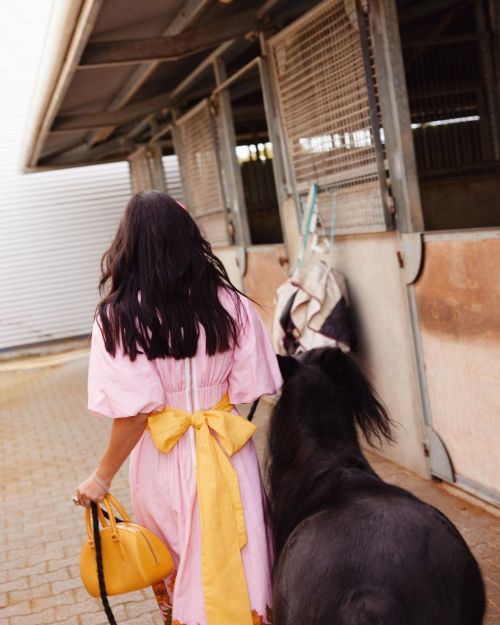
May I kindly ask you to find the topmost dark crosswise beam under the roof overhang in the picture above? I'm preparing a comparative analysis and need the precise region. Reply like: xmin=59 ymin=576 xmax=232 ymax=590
xmin=80 ymin=12 xmax=259 ymax=69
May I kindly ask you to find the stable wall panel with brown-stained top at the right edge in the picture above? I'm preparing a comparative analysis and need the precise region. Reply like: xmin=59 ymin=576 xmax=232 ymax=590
xmin=415 ymin=230 xmax=500 ymax=502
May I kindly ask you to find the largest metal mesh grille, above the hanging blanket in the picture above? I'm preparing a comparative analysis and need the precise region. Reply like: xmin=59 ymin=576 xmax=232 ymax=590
xmin=270 ymin=0 xmax=386 ymax=231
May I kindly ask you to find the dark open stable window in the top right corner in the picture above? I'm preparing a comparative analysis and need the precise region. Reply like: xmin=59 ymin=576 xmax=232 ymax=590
xmin=397 ymin=0 xmax=500 ymax=230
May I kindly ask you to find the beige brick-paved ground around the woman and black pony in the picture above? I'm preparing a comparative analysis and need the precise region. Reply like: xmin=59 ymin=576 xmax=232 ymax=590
xmin=0 ymin=357 xmax=500 ymax=625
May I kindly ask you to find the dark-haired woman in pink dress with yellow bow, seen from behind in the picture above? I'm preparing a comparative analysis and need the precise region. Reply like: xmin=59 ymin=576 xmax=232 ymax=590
xmin=76 ymin=191 xmax=282 ymax=625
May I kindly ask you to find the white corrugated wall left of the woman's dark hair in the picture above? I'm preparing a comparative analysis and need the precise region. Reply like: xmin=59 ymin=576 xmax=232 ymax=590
xmin=0 ymin=163 xmax=130 ymax=349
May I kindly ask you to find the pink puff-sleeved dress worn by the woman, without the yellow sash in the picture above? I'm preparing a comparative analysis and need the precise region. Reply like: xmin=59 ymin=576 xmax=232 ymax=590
xmin=88 ymin=289 xmax=282 ymax=625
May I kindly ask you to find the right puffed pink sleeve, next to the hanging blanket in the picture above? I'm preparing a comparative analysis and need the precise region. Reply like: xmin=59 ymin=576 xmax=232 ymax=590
xmin=228 ymin=298 xmax=283 ymax=404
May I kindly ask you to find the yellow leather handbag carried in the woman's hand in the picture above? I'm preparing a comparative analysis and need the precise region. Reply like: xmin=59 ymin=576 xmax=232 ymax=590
xmin=80 ymin=493 xmax=174 ymax=598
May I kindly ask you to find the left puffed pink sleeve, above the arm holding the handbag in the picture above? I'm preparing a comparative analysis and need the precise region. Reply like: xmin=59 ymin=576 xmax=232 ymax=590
xmin=88 ymin=321 xmax=164 ymax=418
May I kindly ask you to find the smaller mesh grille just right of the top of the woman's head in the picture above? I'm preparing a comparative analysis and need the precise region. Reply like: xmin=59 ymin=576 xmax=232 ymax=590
xmin=177 ymin=101 xmax=230 ymax=245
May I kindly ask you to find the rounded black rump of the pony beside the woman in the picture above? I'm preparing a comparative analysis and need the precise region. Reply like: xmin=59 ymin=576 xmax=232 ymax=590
xmin=273 ymin=488 xmax=485 ymax=625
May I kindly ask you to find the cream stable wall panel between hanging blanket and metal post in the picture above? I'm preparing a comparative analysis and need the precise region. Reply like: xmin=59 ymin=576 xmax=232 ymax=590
xmin=333 ymin=232 xmax=428 ymax=476
